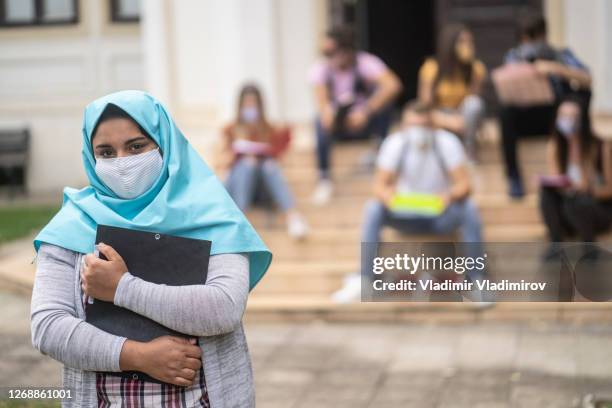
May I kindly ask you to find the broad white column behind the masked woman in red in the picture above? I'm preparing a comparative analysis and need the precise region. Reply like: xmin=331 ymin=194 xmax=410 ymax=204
xmin=173 ymin=0 xmax=279 ymax=123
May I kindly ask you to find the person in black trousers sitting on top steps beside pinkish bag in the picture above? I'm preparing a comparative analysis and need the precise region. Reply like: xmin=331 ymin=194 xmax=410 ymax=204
xmin=499 ymin=15 xmax=591 ymax=198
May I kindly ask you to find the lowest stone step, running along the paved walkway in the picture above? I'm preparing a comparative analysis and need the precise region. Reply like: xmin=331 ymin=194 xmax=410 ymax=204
xmin=246 ymin=295 xmax=612 ymax=325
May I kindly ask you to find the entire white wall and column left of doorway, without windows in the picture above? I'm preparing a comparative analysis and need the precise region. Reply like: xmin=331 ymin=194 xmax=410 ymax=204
xmin=0 ymin=0 xmax=325 ymax=193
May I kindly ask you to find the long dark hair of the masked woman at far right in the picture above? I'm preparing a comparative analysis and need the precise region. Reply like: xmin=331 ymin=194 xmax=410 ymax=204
xmin=551 ymin=94 xmax=602 ymax=172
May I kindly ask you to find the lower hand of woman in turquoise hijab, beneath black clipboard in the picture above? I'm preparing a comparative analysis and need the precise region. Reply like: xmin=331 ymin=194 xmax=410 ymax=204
xmin=119 ymin=336 xmax=202 ymax=386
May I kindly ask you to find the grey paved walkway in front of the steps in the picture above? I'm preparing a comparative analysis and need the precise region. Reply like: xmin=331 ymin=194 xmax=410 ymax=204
xmin=0 ymin=292 xmax=612 ymax=408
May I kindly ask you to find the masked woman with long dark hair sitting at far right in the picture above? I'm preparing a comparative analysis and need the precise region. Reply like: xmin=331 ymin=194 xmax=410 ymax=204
xmin=540 ymin=95 xmax=612 ymax=254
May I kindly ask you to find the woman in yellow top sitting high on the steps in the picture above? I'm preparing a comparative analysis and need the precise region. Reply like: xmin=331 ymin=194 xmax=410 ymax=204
xmin=418 ymin=24 xmax=487 ymax=159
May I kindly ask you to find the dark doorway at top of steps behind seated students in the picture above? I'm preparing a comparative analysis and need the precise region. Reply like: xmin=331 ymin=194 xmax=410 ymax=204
xmin=329 ymin=0 xmax=542 ymax=112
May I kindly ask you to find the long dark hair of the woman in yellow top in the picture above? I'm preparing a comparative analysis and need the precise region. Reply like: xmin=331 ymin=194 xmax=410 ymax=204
xmin=434 ymin=23 xmax=472 ymax=88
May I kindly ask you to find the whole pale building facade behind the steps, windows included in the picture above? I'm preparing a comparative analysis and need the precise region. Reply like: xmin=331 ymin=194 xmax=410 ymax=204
xmin=0 ymin=0 xmax=612 ymax=193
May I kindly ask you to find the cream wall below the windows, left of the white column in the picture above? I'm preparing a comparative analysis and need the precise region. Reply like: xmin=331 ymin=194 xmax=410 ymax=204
xmin=0 ymin=0 xmax=144 ymax=193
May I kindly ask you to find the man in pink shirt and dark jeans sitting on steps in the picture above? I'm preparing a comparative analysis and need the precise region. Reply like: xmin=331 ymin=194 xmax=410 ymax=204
xmin=309 ymin=26 xmax=402 ymax=204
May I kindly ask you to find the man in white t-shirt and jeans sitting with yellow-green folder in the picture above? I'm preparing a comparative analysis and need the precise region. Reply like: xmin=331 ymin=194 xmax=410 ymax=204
xmin=333 ymin=101 xmax=482 ymax=303
